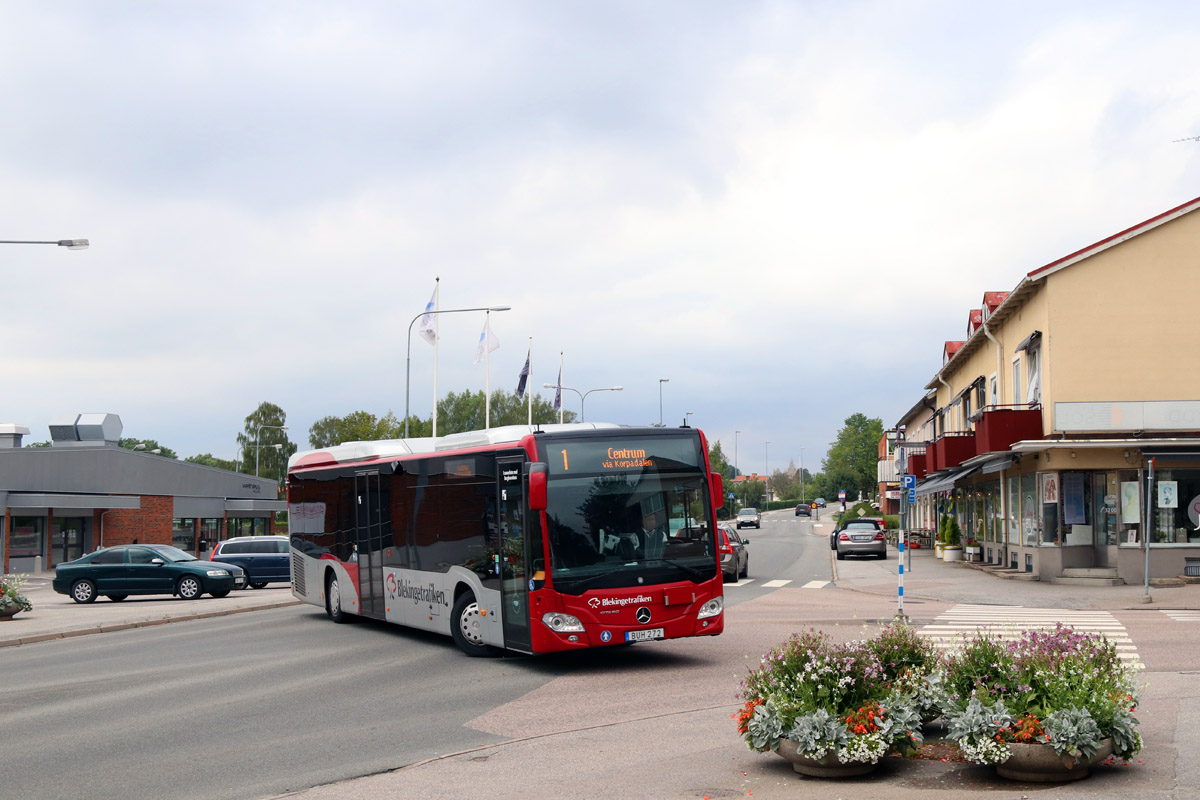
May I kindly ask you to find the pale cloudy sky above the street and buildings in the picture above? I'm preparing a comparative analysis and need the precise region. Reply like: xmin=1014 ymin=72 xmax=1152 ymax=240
xmin=0 ymin=0 xmax=1200 ymax=471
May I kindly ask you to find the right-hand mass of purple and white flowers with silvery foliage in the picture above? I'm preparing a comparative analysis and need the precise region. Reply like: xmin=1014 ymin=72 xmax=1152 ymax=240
xmin=946 ymin=622 xmax=1141 ymax=764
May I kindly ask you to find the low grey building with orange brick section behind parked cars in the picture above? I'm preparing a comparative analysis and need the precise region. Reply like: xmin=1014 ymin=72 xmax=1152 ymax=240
xmin=0 ymin=414 xmax=287 ymax=572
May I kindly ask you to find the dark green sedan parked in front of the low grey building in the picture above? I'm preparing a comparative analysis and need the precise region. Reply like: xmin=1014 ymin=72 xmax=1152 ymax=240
xmin=52 ymin=545 xmax=246 ymax=603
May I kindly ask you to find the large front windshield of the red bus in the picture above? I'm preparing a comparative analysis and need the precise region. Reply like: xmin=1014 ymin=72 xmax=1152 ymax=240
xmin=546 ymin=462 xmax=716 ymax=595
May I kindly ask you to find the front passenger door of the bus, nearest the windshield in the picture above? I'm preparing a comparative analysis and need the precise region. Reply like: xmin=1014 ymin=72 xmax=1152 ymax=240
xmin=496 ymin=457 xmax=530 ymax=652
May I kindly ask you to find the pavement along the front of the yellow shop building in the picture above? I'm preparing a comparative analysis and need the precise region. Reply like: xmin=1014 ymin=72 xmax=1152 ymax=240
xmin=830 ymin=549 xmax=1200 ymax=610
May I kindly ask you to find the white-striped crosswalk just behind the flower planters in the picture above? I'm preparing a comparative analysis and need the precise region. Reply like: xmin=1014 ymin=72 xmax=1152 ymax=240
xmin=917 ymin=603 xmax=1137 ymax=668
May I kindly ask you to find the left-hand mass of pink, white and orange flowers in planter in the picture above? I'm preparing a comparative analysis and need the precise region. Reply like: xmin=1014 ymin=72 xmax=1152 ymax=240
xmin=733 ymin=626 xmax=922 ymax=764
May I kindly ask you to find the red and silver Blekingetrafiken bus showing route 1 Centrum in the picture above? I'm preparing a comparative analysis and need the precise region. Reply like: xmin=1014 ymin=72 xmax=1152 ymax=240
xmin=288 ymin=422 xmax=725 ymax=656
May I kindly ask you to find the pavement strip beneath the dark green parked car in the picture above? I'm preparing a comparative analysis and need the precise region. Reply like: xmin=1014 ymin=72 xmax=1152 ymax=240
xmin=0 ymin=575 xmax=300 ymax=648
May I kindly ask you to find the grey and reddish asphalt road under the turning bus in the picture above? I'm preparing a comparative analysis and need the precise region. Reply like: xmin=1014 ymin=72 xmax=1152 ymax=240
xmin=0 ymin=511 xmax=1200 ymax=800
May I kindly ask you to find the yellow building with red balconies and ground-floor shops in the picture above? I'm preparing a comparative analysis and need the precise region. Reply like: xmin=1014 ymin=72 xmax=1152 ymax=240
xmin=896 ymin=198 xmax=1200 ymax=584
